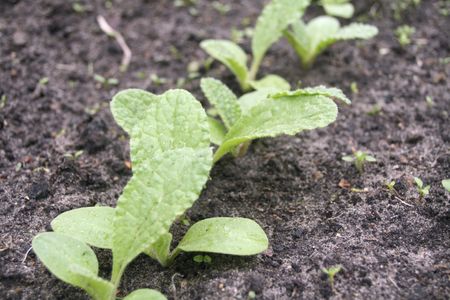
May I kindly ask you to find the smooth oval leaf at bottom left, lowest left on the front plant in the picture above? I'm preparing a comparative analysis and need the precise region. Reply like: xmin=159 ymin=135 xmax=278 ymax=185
xmin=32 ymin=232 xmax=114 ymax=300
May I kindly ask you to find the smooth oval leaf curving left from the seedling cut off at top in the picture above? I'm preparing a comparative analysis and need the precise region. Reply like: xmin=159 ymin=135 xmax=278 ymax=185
xmin=200 ymin=40 xmax=248 ymax=86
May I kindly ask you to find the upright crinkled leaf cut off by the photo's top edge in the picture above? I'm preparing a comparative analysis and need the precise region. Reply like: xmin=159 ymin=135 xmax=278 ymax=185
xmin=252 ymin=0 xmax=310 ymax=62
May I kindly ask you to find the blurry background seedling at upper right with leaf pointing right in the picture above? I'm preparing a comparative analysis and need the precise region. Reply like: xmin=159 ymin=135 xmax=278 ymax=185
xmin=284 ymin=16 xmax=378 ymax=69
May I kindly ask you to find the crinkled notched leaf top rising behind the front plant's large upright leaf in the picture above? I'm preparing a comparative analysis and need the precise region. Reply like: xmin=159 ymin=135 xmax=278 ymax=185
xmin=111 ymin=89 xmax=209 ymax=171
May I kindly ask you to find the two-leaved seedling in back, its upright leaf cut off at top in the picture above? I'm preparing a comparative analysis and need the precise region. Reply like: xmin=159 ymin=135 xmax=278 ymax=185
xmin=200 ymin=0 xmax=310 ymax=91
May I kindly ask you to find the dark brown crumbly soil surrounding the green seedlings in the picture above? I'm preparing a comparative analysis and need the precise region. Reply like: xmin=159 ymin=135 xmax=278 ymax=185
xmin=0 ymin=0 xmax=450 ymax=299
